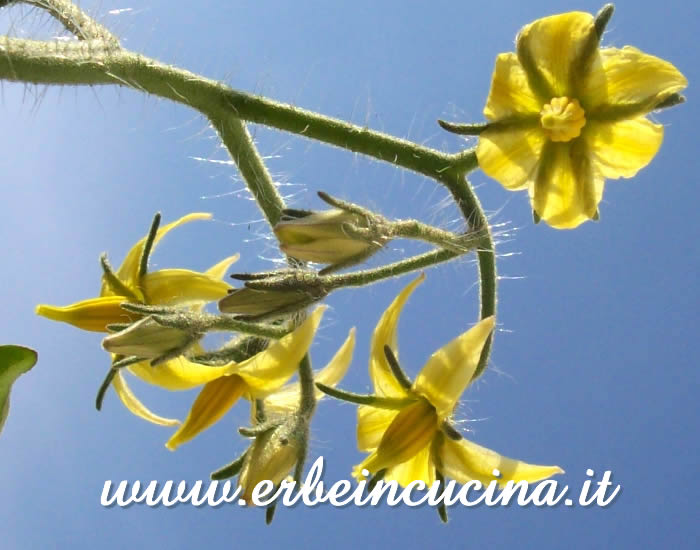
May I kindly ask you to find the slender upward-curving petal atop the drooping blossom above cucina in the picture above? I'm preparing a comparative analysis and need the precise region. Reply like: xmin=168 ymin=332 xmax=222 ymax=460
xmin=369 ymin=274 xmax=425 ymax=397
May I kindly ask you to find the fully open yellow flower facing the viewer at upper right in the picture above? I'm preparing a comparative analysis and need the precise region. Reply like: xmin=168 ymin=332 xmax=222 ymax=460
xmin=476 ymin=8 xmax=687 ymax=229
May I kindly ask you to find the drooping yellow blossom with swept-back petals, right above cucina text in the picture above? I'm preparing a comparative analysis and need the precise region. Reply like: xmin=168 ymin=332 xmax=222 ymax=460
xmin=354 ymin=276 xmax=562 ymax=487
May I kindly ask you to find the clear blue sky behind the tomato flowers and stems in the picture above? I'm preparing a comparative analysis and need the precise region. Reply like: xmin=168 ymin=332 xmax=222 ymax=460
xmin=0 ymin=0 xmax=700 ymax=550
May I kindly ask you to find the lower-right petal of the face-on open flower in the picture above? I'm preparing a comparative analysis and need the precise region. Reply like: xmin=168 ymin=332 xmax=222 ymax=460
xmin=585 ymin=117 xmax=664 ymax=178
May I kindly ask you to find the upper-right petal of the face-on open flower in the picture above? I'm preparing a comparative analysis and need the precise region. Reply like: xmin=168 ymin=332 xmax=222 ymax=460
xmin=581 ymin=46 xmax=688 ymax=108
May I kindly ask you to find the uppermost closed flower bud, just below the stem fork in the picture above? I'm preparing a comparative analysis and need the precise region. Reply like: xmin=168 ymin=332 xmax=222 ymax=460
xmin=273 ymin=208 xmax=383 ymax=264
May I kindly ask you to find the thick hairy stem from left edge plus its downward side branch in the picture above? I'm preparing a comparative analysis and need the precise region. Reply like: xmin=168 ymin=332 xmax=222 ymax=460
xmin=0 ymin=37 xmax=285 ymax=225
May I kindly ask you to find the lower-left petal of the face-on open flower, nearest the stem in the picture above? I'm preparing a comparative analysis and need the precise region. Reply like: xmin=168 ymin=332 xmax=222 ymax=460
xmin=476 ymin=123 xmax=547 ymax=191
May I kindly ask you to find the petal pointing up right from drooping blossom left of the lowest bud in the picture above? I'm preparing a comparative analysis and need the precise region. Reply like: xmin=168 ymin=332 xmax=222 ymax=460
xmin=229 ymin=306 xmax=326 ymax=399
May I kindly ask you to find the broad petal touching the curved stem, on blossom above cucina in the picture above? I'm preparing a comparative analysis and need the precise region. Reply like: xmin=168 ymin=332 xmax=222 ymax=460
xmin=413 ymin=317 xmax=495 ymax=419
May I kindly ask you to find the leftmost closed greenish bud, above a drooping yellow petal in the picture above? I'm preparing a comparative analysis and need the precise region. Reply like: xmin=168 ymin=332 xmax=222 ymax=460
xmin=102 ymin=317 xmax=193 ymax=359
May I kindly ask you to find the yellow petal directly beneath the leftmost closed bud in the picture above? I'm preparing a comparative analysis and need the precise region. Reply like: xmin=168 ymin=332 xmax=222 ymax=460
xmin=127 ymin=357 xmax=232 ymax=391
